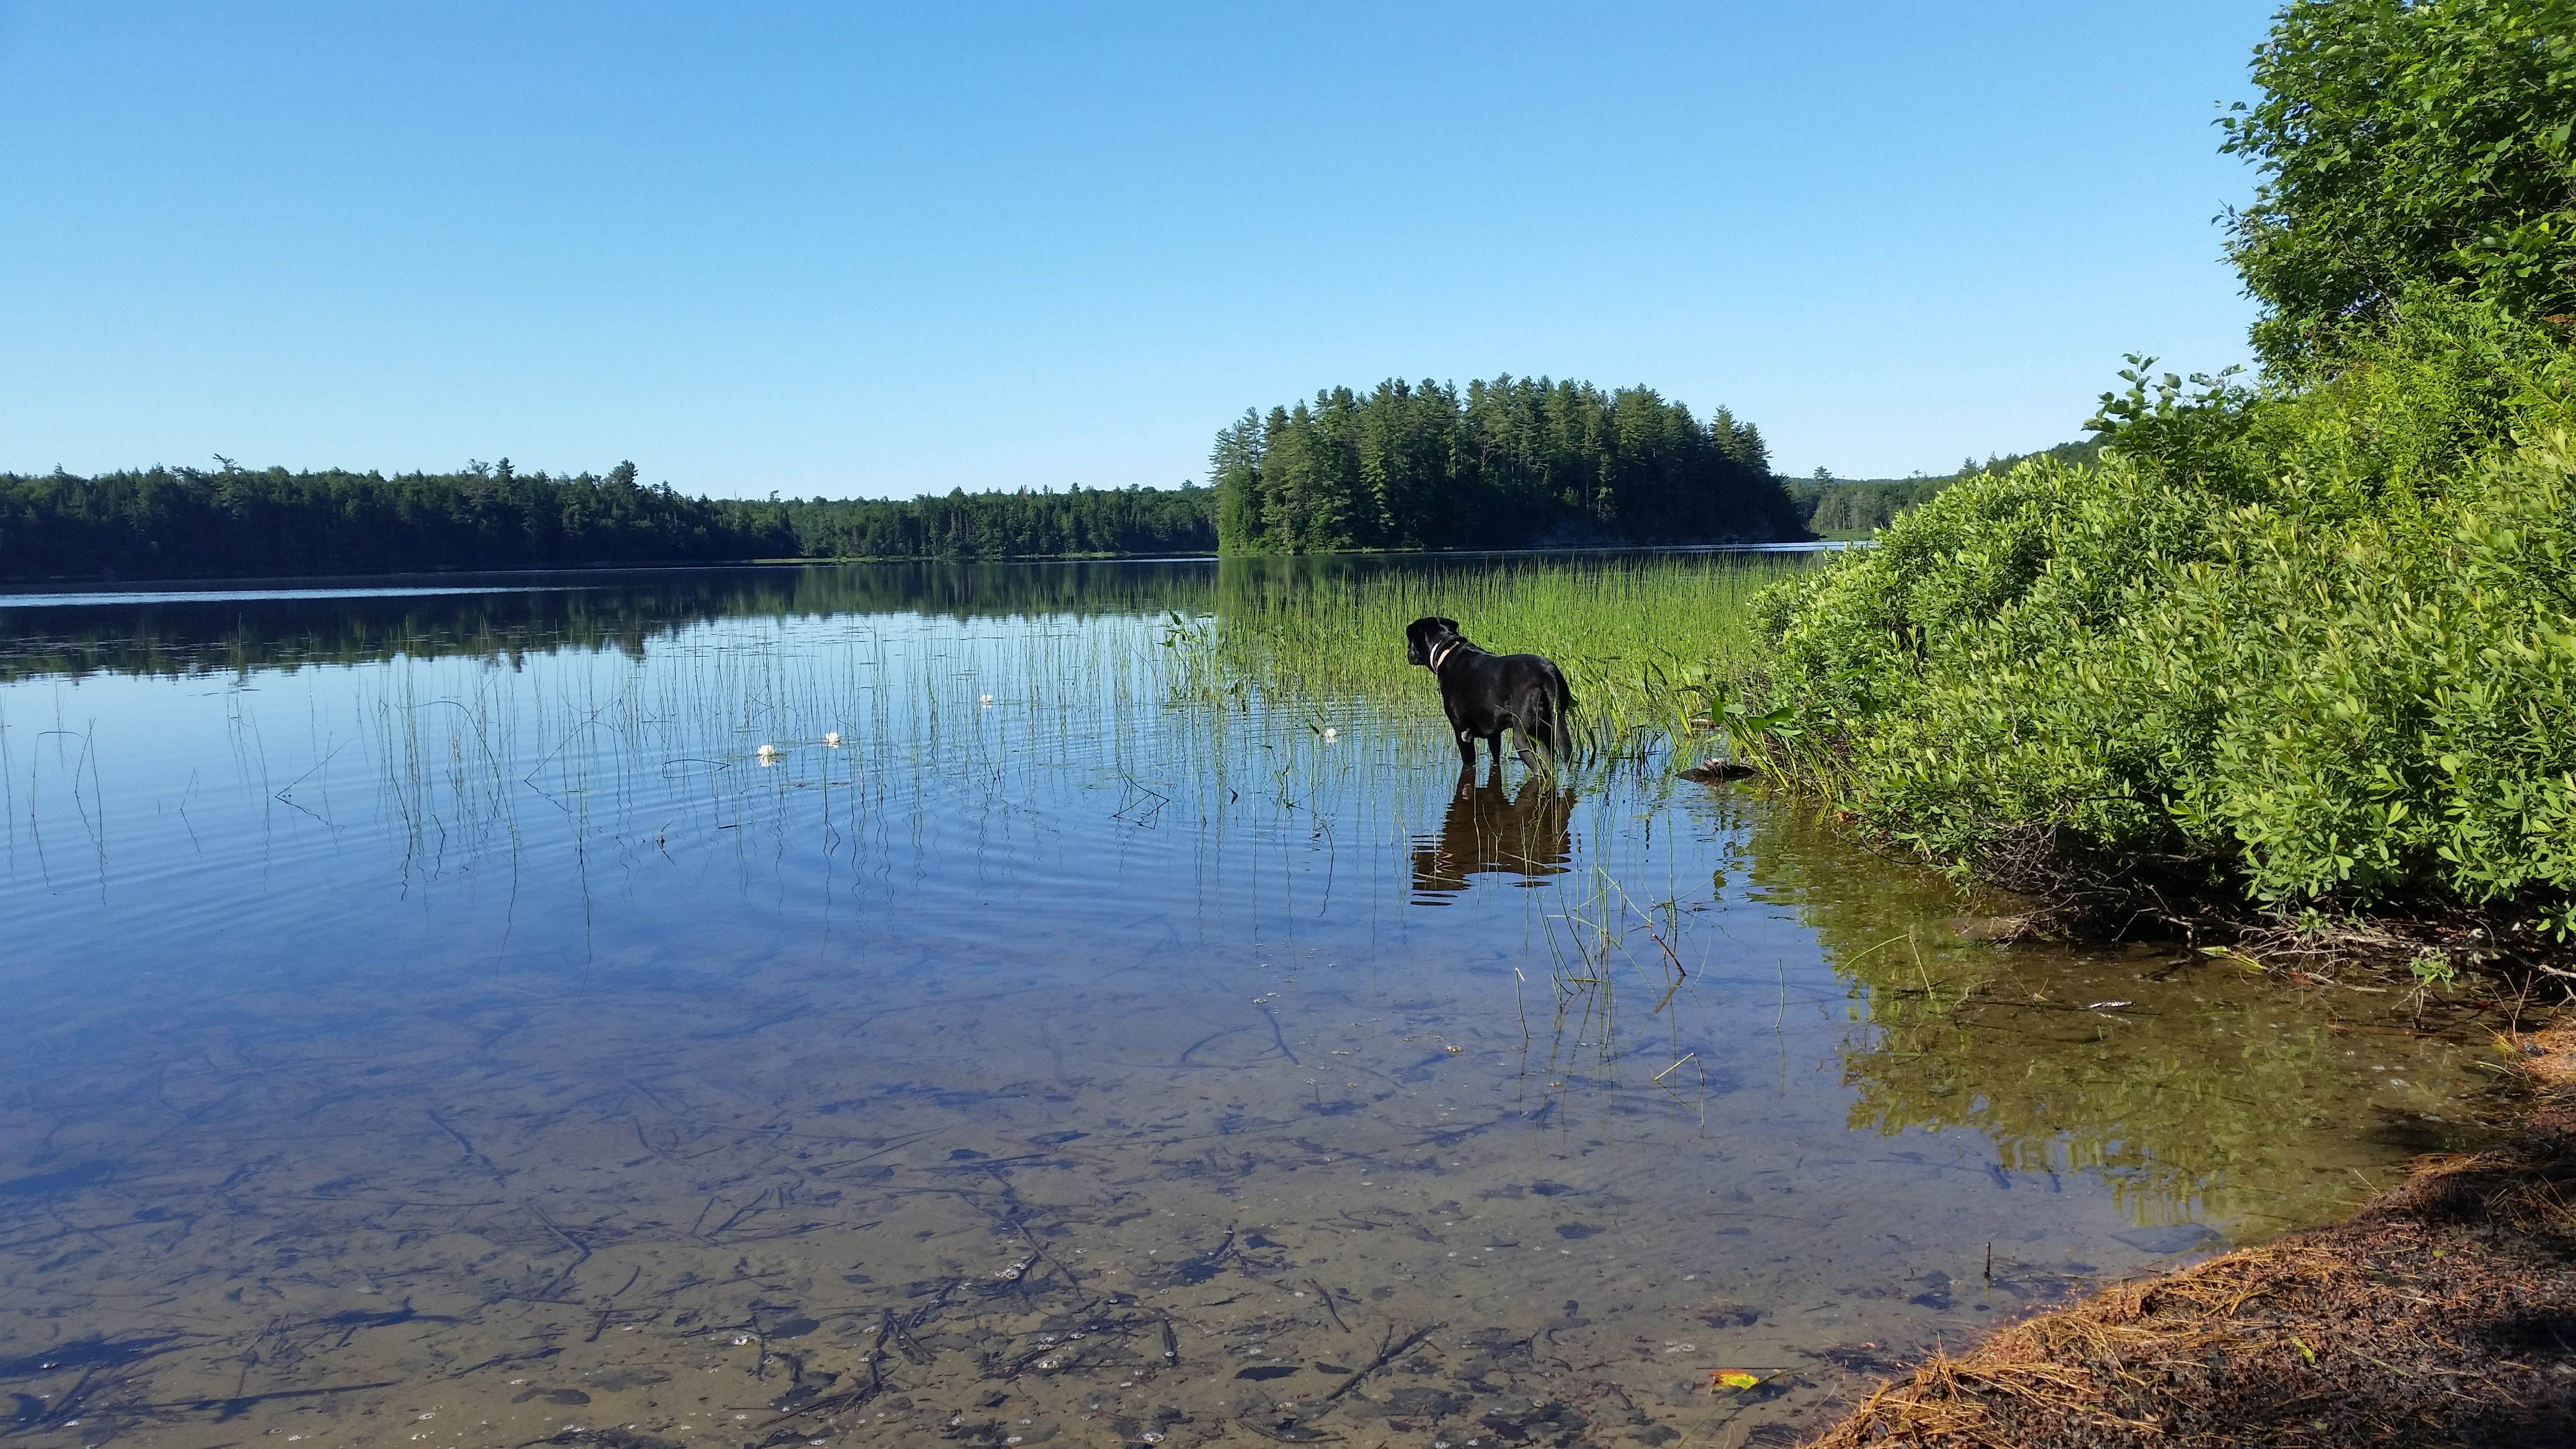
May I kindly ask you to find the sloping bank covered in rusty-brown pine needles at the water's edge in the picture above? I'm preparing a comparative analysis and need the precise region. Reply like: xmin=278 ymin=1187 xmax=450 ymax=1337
xmin=1814 ymin=1024 xmax=2576 ymax=1449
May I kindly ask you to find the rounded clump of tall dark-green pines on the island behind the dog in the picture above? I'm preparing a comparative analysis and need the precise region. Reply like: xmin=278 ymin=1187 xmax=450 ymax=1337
xmin=1208 ymin=376 xmax=1806 ymax=554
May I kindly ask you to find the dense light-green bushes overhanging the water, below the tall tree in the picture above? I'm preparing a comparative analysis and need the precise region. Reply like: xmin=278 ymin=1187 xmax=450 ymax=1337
xmin=1747 ymin=291 xmax=2576 ymax=934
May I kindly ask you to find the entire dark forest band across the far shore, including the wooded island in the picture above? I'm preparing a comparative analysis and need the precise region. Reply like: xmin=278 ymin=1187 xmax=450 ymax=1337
xmin=0 ymin=402 xmax=2094 ymax=580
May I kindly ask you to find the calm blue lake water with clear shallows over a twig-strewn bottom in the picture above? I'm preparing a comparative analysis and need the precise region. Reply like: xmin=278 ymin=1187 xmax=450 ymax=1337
xmin=0 ymin=562 xmax=2499 ymax=1449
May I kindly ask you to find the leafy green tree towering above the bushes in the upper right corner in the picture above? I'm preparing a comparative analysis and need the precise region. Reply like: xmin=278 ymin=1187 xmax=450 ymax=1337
xmin=2221 ymin=0 xmax=2576 ymax=369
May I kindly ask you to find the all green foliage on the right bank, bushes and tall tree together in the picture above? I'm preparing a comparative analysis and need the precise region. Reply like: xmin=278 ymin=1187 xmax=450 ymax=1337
xmin=1734 ymin=0 xmax=2576 ymax=938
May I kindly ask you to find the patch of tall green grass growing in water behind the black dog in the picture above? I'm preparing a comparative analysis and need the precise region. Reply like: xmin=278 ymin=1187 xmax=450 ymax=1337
xmin=1164 ymin=554 xmax=1811 ymax=760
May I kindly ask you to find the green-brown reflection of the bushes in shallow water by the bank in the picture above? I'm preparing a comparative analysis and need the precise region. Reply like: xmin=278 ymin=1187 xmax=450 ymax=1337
xmin=1747 ymin=807 xmax=2480 ymax=1238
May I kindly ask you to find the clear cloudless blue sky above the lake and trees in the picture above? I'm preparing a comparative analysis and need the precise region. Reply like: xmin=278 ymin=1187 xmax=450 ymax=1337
xmin=0 ymin=0 xmax=2270 ymax=495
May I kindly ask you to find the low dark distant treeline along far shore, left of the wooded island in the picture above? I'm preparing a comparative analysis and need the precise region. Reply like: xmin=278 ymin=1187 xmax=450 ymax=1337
xmin=0 ymin=459 xmax=1216 ymax=580
